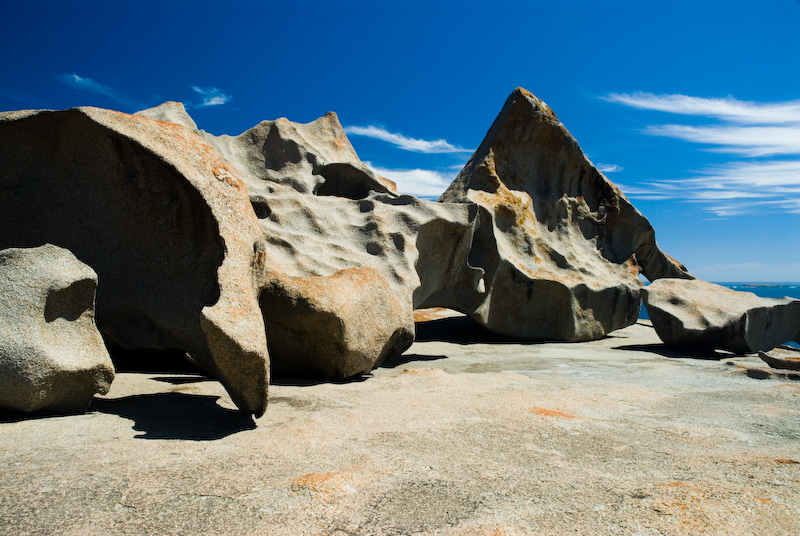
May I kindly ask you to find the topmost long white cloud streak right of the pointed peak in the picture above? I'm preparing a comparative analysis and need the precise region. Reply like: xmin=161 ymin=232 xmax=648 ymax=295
xmin=603 ymin=92 xmax=800 ymax=125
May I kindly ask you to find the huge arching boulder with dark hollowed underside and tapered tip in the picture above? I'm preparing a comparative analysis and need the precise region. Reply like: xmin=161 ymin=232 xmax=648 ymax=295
xmin=0 ymin=104 xmax=269 ymax=415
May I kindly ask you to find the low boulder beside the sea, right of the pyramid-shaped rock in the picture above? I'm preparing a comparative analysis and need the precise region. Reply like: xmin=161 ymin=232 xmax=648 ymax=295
xmin=644 ymin=278 xmax=800 ymax=354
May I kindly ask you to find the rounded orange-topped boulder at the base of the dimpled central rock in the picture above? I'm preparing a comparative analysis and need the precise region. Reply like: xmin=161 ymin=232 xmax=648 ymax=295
xmin=260 ymin=268 xmax=414 ymax=379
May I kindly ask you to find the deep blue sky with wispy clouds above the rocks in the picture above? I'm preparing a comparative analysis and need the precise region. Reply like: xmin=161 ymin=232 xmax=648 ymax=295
xmin=0 ymin=0 xmax=800 ymax=281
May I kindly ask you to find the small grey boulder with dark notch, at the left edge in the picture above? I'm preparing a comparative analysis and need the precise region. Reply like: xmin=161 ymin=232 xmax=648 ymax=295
xmin=0 ymin=244 xmax=114 ymax=413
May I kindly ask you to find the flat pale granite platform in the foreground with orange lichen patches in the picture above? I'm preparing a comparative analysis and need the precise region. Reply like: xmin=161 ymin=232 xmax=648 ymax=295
xmin=0 ymin=317 xmax=800 ymax=536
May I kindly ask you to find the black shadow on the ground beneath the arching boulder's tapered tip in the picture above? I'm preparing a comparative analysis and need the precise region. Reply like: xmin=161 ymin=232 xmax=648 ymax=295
xmin=88 ymin=393 xmax=256 ymax=441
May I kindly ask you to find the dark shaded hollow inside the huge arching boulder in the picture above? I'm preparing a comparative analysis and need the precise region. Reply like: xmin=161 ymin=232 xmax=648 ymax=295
xmin=0 ymin=110 xmax=225 ymax=368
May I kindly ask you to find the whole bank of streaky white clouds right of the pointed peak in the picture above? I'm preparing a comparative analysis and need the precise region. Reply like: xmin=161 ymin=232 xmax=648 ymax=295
xmin=605 ymin=93 xmax=800 ymax=217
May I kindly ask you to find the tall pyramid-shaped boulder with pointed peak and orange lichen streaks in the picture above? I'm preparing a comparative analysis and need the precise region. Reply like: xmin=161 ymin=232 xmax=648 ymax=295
xmin=434 ymin=88 xmax=691 ymax=341
